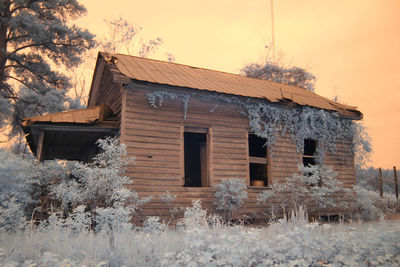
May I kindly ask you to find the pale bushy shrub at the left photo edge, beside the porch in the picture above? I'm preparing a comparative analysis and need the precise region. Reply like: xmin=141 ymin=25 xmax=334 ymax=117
xmin=0 ymin=149 xmax=69 ymax=230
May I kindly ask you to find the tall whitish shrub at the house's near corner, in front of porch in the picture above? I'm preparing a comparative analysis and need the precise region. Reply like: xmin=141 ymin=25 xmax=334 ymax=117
xmin=51 ymin=137 xmax=150 ymax=231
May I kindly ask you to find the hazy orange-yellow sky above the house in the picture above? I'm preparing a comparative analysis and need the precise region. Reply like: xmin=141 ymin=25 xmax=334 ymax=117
xmin=78 ymin=0 xmax=400 ymax=168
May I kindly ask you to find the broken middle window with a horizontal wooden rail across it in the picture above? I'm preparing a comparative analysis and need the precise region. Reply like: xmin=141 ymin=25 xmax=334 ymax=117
xmin=248 ymin=133 xmax=268 ymax=186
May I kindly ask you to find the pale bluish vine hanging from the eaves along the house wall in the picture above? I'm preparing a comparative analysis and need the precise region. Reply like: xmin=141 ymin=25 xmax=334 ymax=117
xmin=147 ymin=91 xmax=360 ymax=163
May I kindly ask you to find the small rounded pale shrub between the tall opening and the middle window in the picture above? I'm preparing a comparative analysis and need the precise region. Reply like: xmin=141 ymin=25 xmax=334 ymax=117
xmin=213 ymin=178 xmax=247 ymax=220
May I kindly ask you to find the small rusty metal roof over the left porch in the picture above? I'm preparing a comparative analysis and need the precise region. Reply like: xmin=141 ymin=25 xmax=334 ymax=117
xmin=21 ymin=104 xmax=113 ymax=127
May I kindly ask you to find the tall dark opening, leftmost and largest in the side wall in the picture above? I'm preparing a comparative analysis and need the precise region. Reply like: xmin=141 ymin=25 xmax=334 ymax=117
xmin=184 ymin=132 xmax=208 ymax=187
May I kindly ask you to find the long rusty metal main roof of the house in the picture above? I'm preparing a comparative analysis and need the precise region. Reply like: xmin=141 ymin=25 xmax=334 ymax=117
xmin=108 ymin=53 xmax=362 ymax=117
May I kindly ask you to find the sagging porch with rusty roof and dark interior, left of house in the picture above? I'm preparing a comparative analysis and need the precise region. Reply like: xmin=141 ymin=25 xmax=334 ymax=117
xmin=21 ymin=104 xmax=119 ymax=161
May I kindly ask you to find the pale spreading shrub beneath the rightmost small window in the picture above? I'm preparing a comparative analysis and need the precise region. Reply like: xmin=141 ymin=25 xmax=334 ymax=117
xmin=257 ymin=164 xmax=353 ymax=218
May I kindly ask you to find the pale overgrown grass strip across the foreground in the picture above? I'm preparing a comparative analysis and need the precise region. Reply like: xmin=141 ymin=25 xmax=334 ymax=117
xmin=0 ymin=210 xmax=400 ymax=266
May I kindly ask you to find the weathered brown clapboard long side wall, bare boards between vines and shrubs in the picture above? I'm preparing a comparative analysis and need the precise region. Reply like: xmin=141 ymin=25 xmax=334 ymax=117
xmin=121 ymin=84 xmax=354 ymax=219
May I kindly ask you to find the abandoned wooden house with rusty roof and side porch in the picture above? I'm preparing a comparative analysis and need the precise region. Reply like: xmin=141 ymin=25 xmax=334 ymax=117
xmin=22 ymin=53 xmax=362 ymax=216
